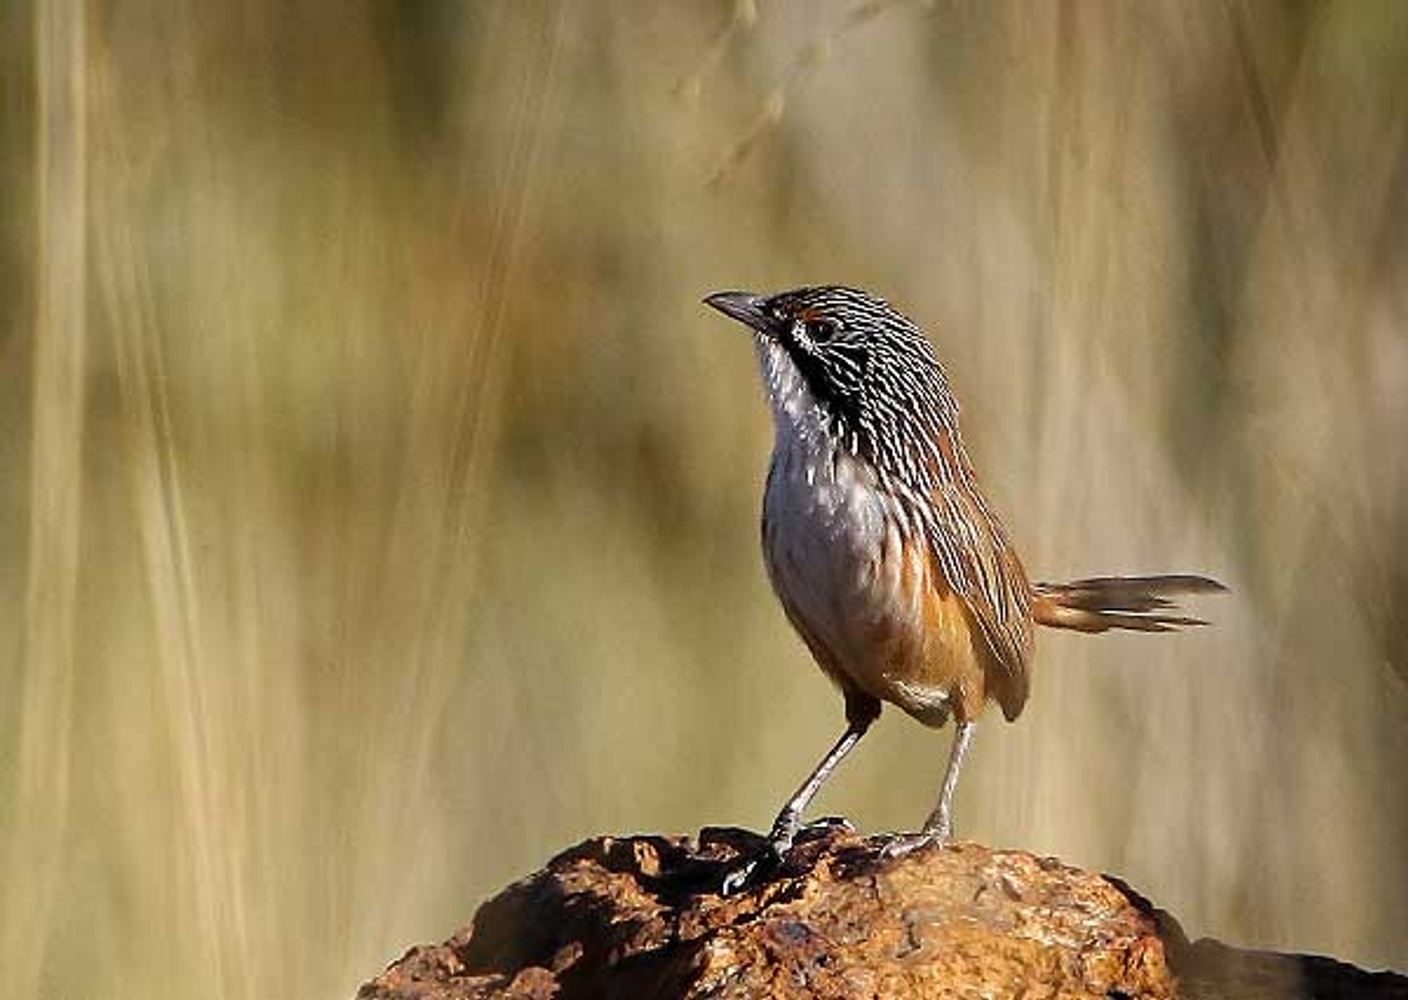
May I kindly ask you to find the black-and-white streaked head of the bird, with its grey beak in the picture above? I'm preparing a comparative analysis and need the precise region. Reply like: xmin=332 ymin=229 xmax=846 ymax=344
xmin=704 ymin=285 xmax=957 ymax=458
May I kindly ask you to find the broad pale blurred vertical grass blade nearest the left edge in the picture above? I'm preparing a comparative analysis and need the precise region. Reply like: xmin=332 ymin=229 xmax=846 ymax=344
xmin=0 ymin=3 xmax=87 ymax=997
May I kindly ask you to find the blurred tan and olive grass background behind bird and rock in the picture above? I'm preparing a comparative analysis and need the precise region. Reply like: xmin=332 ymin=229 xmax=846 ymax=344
xmin=0 ymin=0 xmax=1408 ymax=999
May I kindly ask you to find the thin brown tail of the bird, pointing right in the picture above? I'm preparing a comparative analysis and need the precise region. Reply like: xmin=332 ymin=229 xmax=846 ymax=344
xmin=1032 ymin=575 xmax=1226 ymax=632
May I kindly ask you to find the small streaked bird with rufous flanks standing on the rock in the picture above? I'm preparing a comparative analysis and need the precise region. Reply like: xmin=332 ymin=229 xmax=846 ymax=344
xmin=704 ymin=285 xmax=1225 ymax=892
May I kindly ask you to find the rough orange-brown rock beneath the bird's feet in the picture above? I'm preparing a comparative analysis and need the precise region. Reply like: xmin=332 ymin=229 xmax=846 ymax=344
xmin=358 ymin=830 xmax=1408 ymax=1000
